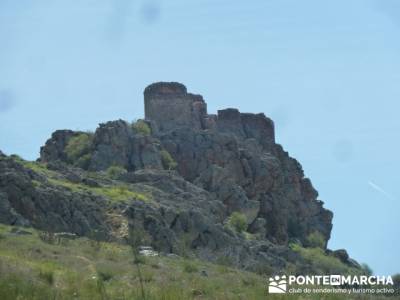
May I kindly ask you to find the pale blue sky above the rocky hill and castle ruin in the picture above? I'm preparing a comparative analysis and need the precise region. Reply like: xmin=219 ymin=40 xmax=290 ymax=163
xmin=0 ymin=0 xmax=400 ymax=275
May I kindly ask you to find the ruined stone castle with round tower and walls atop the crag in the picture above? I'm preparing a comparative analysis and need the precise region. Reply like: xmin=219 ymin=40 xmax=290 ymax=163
xmin=144 ymin=82 xmax=275 ymax=143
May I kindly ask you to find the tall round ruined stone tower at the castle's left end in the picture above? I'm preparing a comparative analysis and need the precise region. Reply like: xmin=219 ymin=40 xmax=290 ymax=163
xmin=144 ymin=82 xmax=207 ymax=131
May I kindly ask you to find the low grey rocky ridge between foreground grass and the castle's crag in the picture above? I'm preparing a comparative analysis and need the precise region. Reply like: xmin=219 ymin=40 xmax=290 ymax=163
xmin=0 ymin=157 xmax=288 ymax=271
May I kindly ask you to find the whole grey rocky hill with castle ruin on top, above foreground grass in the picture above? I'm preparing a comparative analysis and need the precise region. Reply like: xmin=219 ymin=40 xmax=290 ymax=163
xmin=0 ymin=82 xmax=360 ymax=273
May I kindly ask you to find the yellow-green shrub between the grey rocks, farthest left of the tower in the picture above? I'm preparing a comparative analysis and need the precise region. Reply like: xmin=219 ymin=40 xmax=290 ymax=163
xmin=64 ymin=133 xmax=93 ymax=163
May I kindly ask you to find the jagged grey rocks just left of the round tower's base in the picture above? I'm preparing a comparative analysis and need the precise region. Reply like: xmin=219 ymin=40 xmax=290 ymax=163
xmin=40 ymin=120 xmax=163 ymax=171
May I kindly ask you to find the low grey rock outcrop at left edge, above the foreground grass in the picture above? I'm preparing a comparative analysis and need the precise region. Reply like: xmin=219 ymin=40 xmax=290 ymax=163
xmin=0 ymin=157 xmax=109 ymax=236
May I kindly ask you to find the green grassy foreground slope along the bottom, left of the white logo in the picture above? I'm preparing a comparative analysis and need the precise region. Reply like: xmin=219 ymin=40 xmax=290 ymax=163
xmin=0 ymin=225 xmax=393 ymax=300
